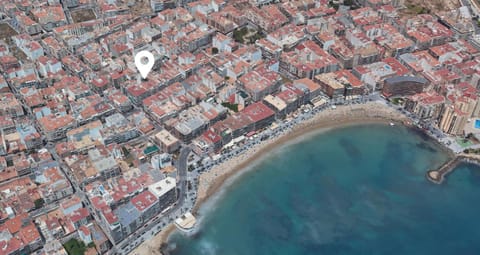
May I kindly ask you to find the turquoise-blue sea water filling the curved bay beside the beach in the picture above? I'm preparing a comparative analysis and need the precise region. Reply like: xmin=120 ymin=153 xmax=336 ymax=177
xmin=170 ymin=124 xmax=480 ymax=255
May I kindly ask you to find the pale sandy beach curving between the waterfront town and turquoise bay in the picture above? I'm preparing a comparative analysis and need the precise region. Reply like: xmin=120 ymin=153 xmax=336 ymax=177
xmin=131 ymin=102 xmax=408 ymax=254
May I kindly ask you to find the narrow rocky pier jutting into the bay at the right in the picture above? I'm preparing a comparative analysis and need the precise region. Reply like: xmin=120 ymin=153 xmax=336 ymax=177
xmin=427 ymin=153 xmax=480 ymax=184
